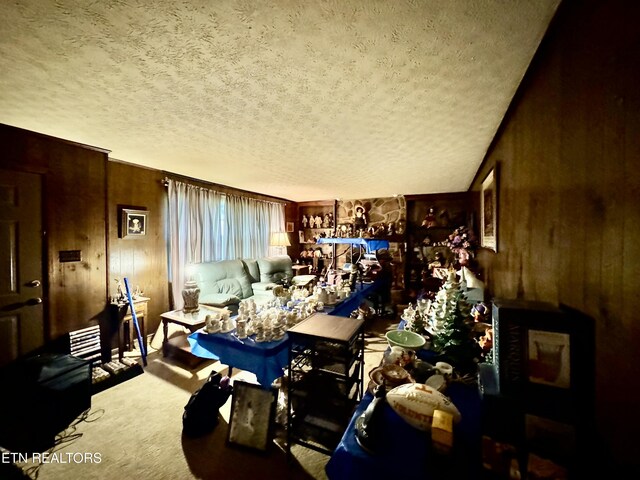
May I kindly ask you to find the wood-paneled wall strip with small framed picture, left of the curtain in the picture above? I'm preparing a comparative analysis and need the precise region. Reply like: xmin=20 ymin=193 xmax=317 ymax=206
xmin=107 ymin=161 xmax=170 ymax=335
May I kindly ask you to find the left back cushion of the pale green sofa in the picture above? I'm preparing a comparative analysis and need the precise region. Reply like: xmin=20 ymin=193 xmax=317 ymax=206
xmin=193 ymin=260 xmax=253 ymax=299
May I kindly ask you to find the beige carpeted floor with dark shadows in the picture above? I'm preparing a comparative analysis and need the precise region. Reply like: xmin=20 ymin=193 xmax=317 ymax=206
xmin=11 ymin=319 xmax=397 ymax=480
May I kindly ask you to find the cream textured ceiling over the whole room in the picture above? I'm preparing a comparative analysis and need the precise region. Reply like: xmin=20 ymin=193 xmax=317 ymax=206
xmin=0 ymin=0 xmax=559 ymax=201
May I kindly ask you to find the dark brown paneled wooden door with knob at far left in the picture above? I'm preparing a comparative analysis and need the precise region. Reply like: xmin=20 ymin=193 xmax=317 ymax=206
xmin=0 ymin=170 xmax=44 ymax=366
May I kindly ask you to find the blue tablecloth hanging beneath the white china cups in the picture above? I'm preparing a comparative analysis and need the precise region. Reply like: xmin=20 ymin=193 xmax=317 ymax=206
xmin=187 ymin=330 xmax=289 ymax=388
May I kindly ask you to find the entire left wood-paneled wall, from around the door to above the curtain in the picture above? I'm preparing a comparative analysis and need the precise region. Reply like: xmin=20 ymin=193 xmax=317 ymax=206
xmin=0 ymin=125 xmax=295 ymax=346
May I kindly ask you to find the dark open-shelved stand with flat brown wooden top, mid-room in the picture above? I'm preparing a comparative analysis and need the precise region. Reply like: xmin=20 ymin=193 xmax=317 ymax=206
xmin=287 ymin=313 xmax=364 ymax=454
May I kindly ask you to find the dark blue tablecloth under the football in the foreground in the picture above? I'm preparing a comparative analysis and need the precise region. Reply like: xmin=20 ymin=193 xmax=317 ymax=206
xmin=325 ymin=384 xmax=481 ymax=480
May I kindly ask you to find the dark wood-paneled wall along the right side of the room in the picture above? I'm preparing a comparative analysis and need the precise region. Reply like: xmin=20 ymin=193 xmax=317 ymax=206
xmin=472 ymin=0 xmax=640 ymax=468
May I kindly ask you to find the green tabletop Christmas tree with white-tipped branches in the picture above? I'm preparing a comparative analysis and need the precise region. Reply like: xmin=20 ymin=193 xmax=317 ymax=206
xmin=428 ymin=272 xmax=480 ymax=373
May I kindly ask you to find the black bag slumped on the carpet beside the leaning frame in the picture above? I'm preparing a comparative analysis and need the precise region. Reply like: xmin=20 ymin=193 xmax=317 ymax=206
xmin=182 ymin=372 xmax=231 ymax=437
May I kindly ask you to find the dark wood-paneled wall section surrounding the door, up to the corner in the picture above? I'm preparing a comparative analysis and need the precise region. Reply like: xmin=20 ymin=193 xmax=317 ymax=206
xmin=0 ymin=125 xmax=108 ymax=340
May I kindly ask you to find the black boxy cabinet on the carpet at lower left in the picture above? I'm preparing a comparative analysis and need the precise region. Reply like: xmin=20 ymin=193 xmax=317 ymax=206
xmin=0 ymin=354 xmax=91 ymax=454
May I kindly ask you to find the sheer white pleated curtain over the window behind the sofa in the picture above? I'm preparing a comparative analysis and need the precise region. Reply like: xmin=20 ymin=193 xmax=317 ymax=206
xmin=167 ymin=180 xmax=286 ymax=309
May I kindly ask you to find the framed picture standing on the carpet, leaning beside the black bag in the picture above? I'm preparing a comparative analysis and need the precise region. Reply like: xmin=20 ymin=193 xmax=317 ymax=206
xmin=227 ymin=380 xmax=276 ymax=452
